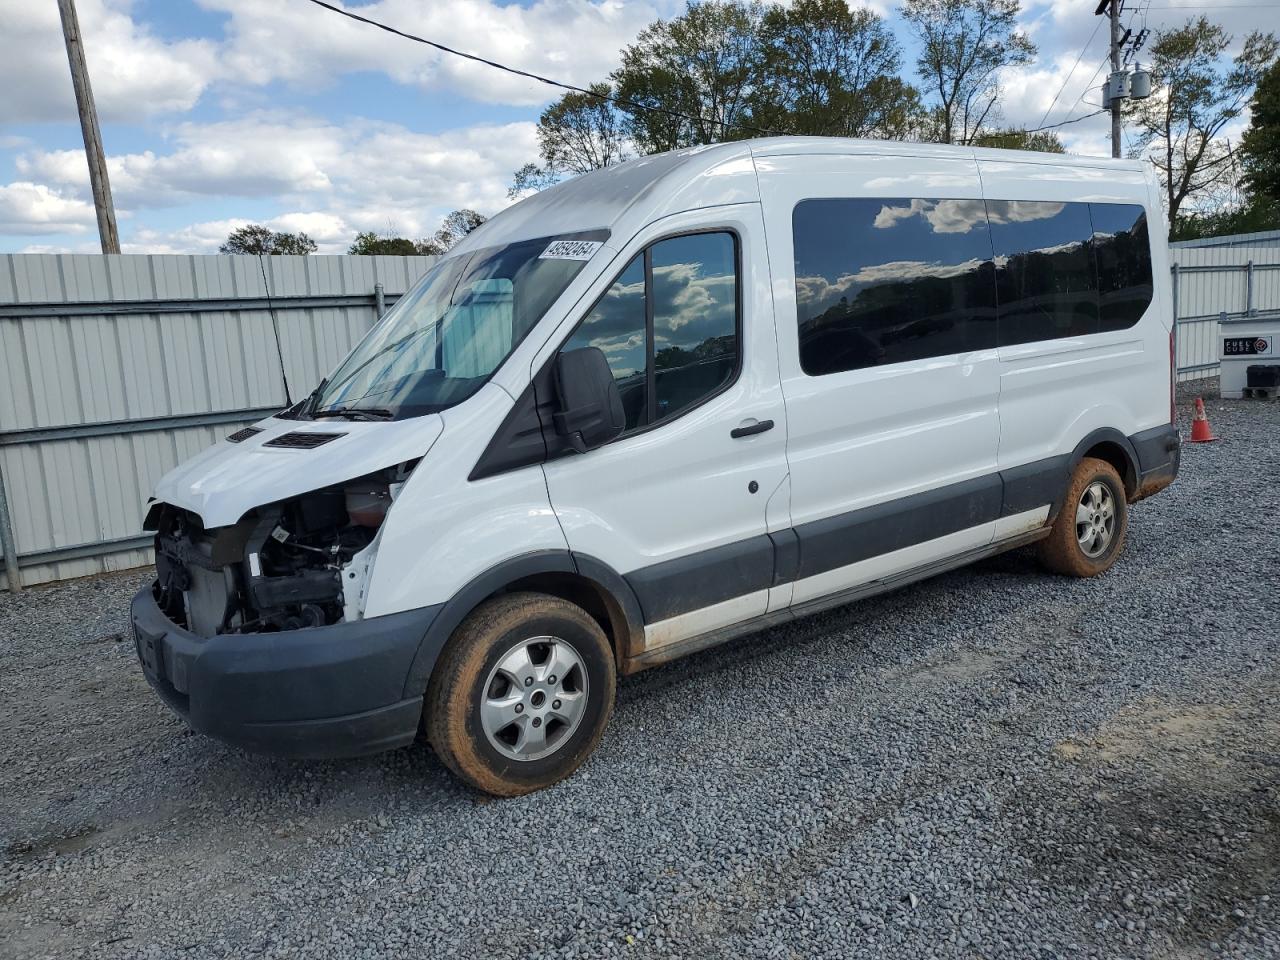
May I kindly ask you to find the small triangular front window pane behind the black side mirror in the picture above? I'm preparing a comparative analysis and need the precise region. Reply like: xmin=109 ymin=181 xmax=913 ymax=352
xmin=561 ymin=253 xmax=649 ymax=430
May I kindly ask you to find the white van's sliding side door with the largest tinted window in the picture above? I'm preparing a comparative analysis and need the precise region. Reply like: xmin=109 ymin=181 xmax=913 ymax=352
xmin=756 ymin=151 xmax=1001 ymax=605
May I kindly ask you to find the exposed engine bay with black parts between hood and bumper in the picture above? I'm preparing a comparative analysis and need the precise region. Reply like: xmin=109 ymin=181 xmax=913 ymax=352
xmin=146 ymin=461 xmax=416 ymax=636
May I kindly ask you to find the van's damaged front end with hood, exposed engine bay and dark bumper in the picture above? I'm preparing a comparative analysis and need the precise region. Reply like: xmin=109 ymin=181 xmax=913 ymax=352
xmin=132 ymin=419 xmax=439 ymax=756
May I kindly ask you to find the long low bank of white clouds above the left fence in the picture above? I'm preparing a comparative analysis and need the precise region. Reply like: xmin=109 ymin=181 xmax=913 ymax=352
xmin=12 ymin=113 xmax=536 ymax=252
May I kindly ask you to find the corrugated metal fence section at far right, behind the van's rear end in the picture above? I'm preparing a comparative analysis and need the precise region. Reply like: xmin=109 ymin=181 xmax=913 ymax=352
xmin=1169 ymin=246 xmax=1280 ymax=381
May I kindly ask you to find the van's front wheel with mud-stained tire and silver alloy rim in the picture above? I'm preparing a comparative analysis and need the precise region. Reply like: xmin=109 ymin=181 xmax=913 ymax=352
xmin=425 ymin=593 xmax=616 ymax=796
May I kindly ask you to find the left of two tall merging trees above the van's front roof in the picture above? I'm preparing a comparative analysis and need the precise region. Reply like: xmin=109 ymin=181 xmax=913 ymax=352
xmin=613 ymin=0 xmax=765 ymax=154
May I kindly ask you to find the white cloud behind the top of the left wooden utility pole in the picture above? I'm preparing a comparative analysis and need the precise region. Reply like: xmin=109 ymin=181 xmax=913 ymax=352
xmin=0 ymin=0 xmax=220 ymax=123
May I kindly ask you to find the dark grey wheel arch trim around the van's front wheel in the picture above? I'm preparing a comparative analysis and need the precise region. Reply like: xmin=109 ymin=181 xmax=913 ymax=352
xmin=404 ymin=550 xmax=644 ymax=699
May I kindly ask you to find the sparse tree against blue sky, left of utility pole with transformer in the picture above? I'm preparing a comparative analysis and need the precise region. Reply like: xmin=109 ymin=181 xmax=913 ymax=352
xmin=901 ymin=0 xmax=1036 ymax=143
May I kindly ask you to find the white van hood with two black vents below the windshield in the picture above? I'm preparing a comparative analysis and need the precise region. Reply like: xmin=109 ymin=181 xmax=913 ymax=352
xmin=155 ymin=413 xmax=444 ymax=529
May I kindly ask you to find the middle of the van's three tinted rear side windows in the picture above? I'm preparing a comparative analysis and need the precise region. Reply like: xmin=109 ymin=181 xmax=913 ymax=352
xmin=987 ymin=200 xmax=1098 ymax=346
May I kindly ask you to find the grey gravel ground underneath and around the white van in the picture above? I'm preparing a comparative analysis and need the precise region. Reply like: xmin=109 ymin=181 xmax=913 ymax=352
xmin=0 ymin=386 xmax=1280 ymax=959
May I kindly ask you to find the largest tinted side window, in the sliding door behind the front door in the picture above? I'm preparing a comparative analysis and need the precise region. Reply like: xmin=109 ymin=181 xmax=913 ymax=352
xmin=791 ymin=198 xmax=996 ymax=376
